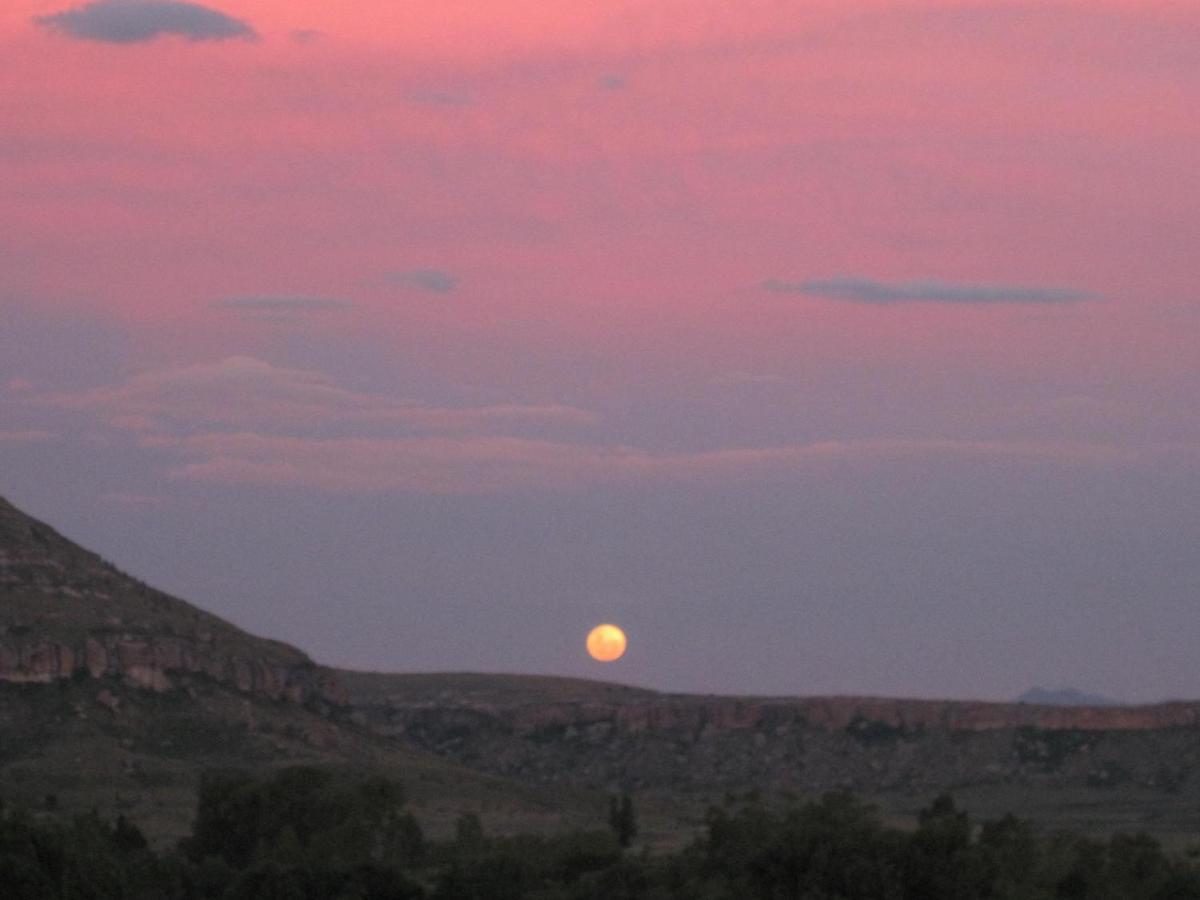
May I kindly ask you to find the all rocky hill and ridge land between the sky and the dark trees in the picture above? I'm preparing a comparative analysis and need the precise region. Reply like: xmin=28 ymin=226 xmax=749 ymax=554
xmin=0 ymin=500 xmax=1200 ymax=840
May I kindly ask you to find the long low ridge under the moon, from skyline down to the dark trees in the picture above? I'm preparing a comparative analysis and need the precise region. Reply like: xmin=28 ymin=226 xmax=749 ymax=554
xmin=342 ymin=673 xmax=1200 ymax=840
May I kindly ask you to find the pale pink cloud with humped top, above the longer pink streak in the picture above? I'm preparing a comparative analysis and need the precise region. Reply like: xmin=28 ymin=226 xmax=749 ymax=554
xmin=34 ymin=356 xmax=596 ymax=433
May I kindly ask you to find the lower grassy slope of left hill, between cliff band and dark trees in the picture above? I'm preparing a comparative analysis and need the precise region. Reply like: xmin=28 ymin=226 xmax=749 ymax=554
xmin=0 ymin=679 xmax=604 ymax=844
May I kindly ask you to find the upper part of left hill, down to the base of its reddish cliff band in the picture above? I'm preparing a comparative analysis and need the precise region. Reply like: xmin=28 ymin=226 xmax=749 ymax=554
xmin=0 ymin=499 xmax=346 ymax=704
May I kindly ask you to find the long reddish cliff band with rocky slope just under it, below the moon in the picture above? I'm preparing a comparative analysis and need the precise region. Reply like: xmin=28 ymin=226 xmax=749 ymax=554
xmin=347 ymin=676 xmax=1200 ymax=792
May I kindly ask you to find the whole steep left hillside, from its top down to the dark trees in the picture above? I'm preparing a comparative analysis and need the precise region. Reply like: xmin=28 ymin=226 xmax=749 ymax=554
xmin=0 ymin=499 xmax=604 ymax=841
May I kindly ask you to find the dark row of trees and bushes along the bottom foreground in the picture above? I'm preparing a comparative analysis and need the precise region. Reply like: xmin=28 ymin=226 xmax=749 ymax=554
xmin=0 ymin=768 xmax=1200 ymax=900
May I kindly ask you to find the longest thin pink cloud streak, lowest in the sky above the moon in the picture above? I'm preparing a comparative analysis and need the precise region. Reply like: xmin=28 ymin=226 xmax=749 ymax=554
xmin=143 ymin=433 xmax=1138 ymax=493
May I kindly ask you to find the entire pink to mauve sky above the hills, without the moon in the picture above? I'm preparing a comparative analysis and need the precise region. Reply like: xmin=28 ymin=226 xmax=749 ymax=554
xmin=0 ymin=0 xmax=1200 ymax=700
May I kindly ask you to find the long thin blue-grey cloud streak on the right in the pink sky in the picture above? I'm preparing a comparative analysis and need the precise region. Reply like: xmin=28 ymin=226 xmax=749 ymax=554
xmin=762 ymin=277 xmax=1092 ymax=306
